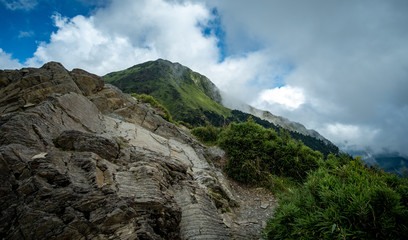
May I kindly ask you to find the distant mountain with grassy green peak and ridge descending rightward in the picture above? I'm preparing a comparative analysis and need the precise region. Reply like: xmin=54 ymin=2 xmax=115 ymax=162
xmin=103 ymin=59 xmax=339 ymax=155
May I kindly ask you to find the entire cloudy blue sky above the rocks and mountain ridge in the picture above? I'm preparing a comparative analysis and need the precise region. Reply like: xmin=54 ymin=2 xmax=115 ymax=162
xmin=0 ymin=0 xmax=408 ymax=158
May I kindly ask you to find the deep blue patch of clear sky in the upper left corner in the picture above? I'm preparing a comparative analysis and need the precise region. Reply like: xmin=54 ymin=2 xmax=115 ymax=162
xmin=0 ymin=0 xmax=103 ymax=62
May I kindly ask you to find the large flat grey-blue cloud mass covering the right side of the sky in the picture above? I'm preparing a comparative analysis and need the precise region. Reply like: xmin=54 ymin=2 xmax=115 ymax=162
xmin=203 ymin=0 xmax=408 ymax=153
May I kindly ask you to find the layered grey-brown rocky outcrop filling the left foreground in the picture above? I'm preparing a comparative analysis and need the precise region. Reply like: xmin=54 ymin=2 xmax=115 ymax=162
xmin=0 ymin=62 xmax=274 ymax=239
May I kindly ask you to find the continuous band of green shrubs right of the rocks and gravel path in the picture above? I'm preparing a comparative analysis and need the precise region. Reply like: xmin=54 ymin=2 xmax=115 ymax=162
xmin=192 ymin=119 xmax=408 ymax=239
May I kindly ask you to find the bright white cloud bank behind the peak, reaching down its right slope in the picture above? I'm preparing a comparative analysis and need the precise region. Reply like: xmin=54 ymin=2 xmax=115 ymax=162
xmin=27 ymin=0 xmax=282 ymax=108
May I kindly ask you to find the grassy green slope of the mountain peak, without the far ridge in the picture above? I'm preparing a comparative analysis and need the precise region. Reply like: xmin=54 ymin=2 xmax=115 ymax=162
xmin=103 ymin=59 xmax=231 ymax=126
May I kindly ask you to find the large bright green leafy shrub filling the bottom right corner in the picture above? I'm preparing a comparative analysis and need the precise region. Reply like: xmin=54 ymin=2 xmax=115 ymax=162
xmin=265 ymin=156 xmax=408 ymax=239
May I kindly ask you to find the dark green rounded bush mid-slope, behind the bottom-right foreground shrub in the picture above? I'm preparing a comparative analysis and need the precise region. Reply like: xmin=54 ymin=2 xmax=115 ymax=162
xmin=218 ymin=119 xmax=322 ymax=183
